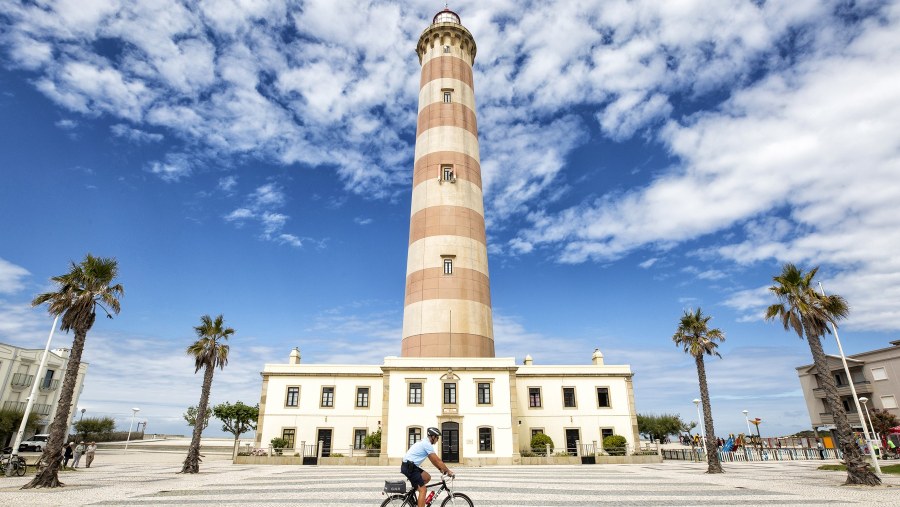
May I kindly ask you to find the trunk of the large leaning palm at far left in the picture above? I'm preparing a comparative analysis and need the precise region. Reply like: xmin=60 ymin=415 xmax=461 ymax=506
xmin=22 ymin=326 xmax=93 ymax=489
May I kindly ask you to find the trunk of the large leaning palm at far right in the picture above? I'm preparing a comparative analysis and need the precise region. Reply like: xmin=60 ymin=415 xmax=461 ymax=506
xmin=806 ymin=336 xmax=881 ymax=486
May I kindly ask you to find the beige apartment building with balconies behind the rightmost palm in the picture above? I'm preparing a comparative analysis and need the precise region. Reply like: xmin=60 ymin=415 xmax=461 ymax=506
xmin=797 ymin=340 xmax=900 ymax=430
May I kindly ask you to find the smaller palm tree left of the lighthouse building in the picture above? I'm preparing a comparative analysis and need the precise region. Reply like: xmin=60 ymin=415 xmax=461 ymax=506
xmin=181 ymin=315 xmax=234 ymax=474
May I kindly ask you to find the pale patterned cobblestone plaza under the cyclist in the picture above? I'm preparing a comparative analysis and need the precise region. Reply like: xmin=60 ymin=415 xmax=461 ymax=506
xmin=0 ymin=454 xmax=900 ymax=507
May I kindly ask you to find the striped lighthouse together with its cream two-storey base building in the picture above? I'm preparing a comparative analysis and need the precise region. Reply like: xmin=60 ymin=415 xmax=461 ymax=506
xmin=255 ymin=10 xmax=638 ymax=465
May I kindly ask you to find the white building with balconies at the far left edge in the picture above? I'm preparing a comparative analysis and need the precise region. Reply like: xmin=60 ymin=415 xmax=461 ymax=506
xmin=0 ymin=343 xmax=88 ymax=433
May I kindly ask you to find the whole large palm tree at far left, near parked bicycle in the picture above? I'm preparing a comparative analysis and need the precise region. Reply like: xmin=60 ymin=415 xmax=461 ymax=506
xmin=22 ymin=254 xmax=125 ymax=489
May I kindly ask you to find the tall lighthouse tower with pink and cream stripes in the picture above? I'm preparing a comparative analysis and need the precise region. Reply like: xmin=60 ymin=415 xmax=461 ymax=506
xmin=401 ymin=9 xmax=494 ymax=357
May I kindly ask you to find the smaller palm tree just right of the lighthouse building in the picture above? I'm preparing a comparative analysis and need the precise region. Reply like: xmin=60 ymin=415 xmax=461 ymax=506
xmin=672 ymin=308 xmax=725 ymax=474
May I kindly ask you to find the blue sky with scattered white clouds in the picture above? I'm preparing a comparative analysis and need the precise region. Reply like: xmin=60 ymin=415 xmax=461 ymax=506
xmin=0 ymin=0 xmax=900 ymax=436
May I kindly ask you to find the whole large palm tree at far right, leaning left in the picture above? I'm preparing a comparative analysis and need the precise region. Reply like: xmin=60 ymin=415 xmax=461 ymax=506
xmin=766 ymin=263 xmax=881 ymax=486
